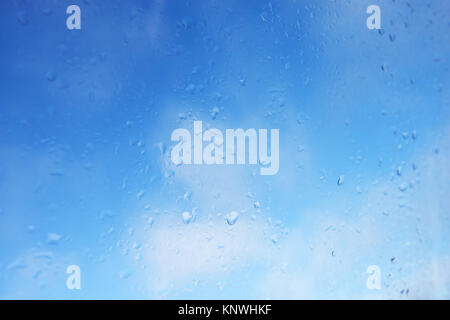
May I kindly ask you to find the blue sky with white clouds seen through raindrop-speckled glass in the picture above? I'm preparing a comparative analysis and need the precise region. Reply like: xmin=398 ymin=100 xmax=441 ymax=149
xmin=0 ymin=0 xmax=450 ymax=299
